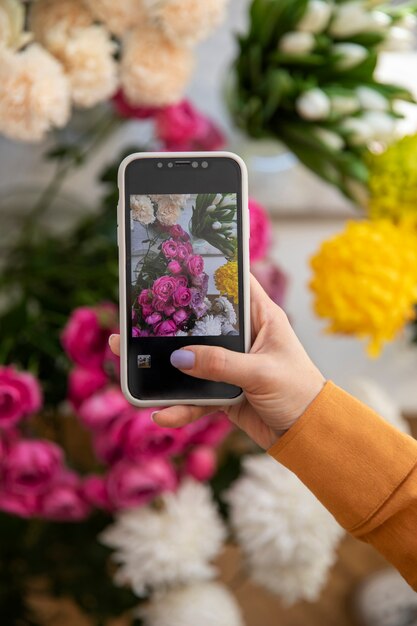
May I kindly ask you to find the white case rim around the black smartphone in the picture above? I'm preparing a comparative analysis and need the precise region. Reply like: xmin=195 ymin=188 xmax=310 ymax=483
xmin=117 ymin=152 xmax=251 ymax=408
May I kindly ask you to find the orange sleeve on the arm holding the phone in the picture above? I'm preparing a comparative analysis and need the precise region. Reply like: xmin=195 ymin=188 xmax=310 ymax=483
xmin=268 ymin=382 xmax=417 ymax=591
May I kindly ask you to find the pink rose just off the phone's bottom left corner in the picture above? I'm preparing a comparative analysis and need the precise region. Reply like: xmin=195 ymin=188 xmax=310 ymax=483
xmin=78 ymin=387 xmax=130 ymax=430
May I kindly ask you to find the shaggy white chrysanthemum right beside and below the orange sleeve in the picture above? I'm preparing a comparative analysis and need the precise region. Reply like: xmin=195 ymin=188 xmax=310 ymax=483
xmin=226 ymin=455 xmax=344 ymax=604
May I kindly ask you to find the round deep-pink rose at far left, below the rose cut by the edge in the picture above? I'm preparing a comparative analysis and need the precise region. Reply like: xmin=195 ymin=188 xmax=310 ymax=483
xmin=3 ymin=439 xmax=63 ymax=495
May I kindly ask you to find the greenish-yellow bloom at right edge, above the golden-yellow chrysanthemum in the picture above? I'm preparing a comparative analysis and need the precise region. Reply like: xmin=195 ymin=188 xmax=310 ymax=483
xmin=368 ymin=135 xmax=417 ymax=224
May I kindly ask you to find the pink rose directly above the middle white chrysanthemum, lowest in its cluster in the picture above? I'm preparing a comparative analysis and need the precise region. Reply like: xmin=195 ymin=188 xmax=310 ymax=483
xmin=107 ymin=458 xmax=177 ymax=509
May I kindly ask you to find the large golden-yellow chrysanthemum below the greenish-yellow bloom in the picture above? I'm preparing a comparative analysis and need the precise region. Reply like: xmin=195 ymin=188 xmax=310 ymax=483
xmin=310 ymin=220 xmax=417 ymax=356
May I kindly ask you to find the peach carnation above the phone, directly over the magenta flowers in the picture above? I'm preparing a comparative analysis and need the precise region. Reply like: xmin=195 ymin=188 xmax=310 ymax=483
xmin=121 ymin=28 xmax=193 ymax=106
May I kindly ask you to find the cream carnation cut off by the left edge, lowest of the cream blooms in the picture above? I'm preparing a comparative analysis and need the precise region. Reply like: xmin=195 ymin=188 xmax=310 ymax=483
xmin=0 ymin=44 xmax=70 ymax=141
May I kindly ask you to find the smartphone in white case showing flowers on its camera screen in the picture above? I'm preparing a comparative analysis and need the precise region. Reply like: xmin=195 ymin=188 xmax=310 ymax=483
xmin=118 ymin=152 xmax=250 ymax=407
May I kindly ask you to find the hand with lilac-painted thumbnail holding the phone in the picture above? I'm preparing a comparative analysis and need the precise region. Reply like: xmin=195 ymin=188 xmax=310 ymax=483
xmin=110 ymin=276 xmax=325 ymax=449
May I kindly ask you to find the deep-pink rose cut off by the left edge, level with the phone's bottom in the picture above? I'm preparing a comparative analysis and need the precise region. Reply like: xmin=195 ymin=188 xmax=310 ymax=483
xmin=0 ymin=366 xmax=42 ymax=429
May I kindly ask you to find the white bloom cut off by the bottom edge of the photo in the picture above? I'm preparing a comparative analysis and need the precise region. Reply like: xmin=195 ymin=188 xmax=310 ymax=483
xmin=138 ymin=582 xmax=244 ymax=626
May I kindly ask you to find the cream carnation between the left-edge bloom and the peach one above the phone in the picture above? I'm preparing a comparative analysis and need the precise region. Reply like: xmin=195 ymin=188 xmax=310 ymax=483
xmin=53 ymin=25 xmax=118 ymax=107
